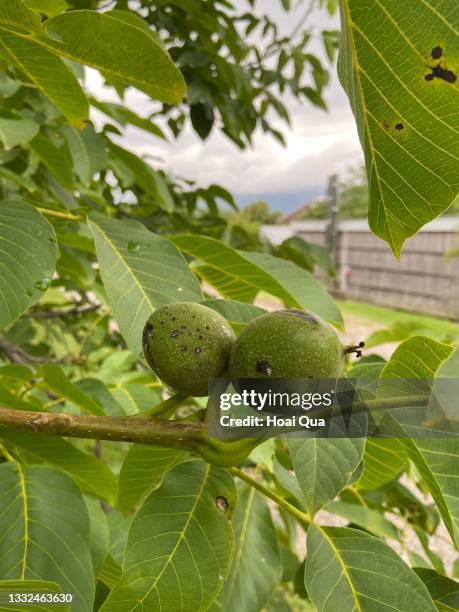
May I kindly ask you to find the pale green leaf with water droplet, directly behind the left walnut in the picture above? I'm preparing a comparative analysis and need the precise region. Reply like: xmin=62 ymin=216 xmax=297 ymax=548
xmin=88 ymin=214 xmax=202 ymax=354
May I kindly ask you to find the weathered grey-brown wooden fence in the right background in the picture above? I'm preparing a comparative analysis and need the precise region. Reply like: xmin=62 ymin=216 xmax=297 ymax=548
xmin=262 ymin=216 xmax=459 ymax=320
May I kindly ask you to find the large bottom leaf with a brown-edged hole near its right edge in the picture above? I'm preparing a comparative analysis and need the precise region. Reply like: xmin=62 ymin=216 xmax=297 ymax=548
xmin=102 ymin=461 xmax=236 ymax=612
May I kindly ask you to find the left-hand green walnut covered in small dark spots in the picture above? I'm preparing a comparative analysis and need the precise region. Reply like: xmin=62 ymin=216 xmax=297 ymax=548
xmin=143 ymin=302 xmax=236 ymax=396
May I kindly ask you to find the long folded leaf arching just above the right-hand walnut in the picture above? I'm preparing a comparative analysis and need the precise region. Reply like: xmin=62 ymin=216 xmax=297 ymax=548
xmin=170 ymin=235 xmax=342 ymax=325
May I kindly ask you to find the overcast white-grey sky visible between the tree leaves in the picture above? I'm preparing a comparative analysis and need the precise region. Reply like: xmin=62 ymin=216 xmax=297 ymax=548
xmin=87 ymin=0 xmax=362 ymax=211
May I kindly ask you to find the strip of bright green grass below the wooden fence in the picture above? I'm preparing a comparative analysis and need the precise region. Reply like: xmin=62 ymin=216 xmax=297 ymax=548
xmin=337 ymin=300 xmax=459 ymax=339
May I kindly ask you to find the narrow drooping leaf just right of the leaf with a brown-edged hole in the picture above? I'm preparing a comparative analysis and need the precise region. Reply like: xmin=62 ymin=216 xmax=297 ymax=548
xmin=219 ymin=487 xmax=282 ymax=612
